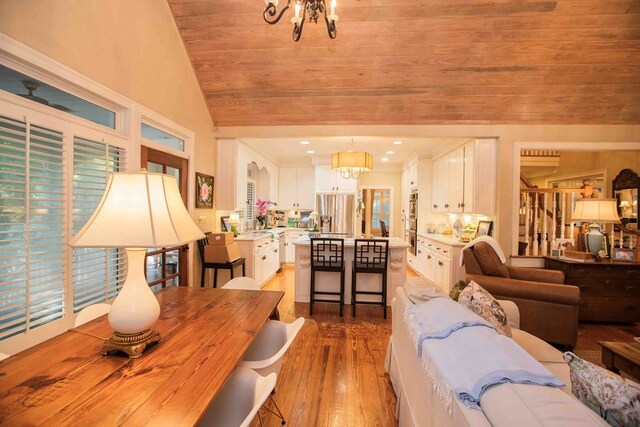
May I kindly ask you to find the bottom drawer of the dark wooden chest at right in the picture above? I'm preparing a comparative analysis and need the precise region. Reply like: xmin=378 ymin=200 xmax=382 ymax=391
xmin=579 ymin=296 xmax=640 ymax=322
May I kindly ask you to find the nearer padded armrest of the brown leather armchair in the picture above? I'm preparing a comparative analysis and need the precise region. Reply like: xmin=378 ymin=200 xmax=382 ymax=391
xmin=467 ymin=274 xmax=580 ymax=306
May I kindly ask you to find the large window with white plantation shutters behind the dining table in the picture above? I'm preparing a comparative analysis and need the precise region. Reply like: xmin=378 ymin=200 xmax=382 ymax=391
xmin=0 ymin=109 xmax=125 ymax=340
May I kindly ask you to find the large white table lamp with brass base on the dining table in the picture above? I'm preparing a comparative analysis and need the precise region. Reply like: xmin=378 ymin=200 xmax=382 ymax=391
xmin=69 ymin=172 xmax=204 ymax=358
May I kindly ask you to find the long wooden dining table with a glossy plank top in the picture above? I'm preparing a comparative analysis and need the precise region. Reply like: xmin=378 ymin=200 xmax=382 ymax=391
xmin=0 ymin=287 xmax=284 ymax=426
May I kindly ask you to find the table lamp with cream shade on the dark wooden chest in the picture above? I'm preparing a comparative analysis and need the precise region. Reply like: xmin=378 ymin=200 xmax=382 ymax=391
xmin=571 ymin=199 xmax=620 ymax=255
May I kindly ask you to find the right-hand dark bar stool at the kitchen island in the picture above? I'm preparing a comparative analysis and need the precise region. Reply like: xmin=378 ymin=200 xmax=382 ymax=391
xmin=351 ymin=239 xmax=389 ymax=319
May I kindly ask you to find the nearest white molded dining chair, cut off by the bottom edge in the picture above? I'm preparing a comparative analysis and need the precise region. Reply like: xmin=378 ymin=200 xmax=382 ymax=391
xmin=199 ymin=367 xmax=276 ymax=427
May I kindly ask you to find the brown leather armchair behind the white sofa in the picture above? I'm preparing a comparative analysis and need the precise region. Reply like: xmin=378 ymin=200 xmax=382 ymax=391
xmin=463 ymin=242 xmax=580 ymax=348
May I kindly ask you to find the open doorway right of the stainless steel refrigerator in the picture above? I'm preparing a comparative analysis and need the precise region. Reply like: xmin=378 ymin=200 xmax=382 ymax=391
xmin=362 ymin=187 xmax=392 ymax=237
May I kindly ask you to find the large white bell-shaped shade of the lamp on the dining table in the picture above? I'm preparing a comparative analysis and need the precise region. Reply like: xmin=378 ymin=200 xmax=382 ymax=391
xmin=69 ymin=172 xmax=204 ymax=248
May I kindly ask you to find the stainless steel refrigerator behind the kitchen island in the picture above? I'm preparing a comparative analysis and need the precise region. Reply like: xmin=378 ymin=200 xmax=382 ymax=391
xmin=316 ymin=194 xmax=356 ymax=235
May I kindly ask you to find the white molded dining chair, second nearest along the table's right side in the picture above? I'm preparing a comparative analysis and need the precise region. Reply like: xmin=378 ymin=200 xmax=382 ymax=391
xmin=238 ymin=317 xmax=304 ymax=425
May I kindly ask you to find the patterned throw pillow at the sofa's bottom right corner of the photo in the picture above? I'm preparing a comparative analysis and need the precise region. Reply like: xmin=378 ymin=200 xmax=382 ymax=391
xmin=564 ymin=351 xmax=640 ymax=426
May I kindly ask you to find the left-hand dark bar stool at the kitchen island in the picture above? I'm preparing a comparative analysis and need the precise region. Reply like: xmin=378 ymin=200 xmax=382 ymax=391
xmin=309 ymin=237 xmax=344 ymax=317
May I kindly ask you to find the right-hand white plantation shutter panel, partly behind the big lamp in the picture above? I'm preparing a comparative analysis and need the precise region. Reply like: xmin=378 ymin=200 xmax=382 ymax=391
xmin=73 ymin=136 xmax=126 ymax=312
